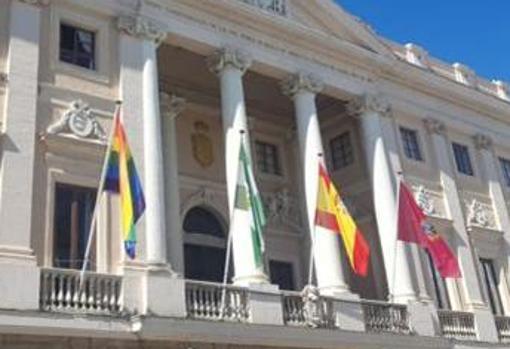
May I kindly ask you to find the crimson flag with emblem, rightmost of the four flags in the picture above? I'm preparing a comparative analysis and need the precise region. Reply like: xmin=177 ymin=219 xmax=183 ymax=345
xmin=397 ymin=182 xmax=461 ymax=278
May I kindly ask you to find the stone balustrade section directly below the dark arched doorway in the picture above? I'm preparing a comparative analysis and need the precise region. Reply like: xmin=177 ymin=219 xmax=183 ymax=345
xmin=186 ymin=281 xmax=249 ymax=322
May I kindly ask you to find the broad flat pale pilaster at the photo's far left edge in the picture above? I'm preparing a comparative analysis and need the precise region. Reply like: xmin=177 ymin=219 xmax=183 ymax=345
xmin=0 ymin=1 xmax=47 ymax=310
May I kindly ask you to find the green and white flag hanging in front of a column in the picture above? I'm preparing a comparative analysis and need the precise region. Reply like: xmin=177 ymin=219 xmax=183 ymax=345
xmin=233 ymin=142 xmax=266 ymax=267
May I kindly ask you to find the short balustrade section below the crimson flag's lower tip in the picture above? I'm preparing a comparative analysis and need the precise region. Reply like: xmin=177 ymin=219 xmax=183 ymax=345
xmin=437 ymin=310 xmax=476 ymax=340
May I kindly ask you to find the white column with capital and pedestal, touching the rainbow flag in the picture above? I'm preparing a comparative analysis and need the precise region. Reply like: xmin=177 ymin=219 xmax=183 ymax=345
xmin=117 ymin=16 xmax=186 ymax=316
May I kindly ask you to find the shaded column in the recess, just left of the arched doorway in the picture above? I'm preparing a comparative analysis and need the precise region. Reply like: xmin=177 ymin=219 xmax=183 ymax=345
xmin=160 ymin=92 xmax=186 ymax=275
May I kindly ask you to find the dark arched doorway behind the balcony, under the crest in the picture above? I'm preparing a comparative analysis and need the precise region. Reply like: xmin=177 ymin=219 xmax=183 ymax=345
xmin=183 ymin=206 xmax=226 ymax=282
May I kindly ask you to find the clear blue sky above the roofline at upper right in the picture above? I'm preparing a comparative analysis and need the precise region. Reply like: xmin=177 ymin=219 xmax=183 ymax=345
xmin=335 ymin=0 xmax=510 ymax=82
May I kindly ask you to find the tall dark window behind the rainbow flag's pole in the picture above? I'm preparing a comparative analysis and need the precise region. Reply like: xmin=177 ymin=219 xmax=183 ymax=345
xmin=53 ymin=184 xmax=96 ymax=269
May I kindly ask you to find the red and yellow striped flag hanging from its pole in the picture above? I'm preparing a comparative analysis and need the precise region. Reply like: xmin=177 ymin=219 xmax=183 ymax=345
xmin=315 ymin=164 xmax=370 ymax=276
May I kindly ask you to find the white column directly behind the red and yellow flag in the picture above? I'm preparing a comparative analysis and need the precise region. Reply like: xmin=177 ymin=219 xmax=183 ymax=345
xmin=282 ymin=73 xmax=349 ymax=295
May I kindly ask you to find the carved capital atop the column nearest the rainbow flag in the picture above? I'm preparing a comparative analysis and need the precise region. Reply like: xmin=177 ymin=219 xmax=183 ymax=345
xmin=117 ymin=15 xmax=167 ymax=45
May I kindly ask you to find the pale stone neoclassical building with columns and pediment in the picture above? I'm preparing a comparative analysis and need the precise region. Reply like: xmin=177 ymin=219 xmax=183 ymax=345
xmin=0 ymin=0 xmax=510 ymax=349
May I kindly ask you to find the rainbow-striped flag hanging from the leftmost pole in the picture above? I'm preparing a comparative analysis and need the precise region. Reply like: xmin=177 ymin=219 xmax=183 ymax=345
xmin=104 ymin=107 xmax=145 ymax=259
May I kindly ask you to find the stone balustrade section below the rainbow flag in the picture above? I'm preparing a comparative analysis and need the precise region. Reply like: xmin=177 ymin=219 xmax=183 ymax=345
xmin=39 ymin=268 xmax=122 ymax=315
